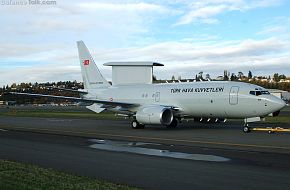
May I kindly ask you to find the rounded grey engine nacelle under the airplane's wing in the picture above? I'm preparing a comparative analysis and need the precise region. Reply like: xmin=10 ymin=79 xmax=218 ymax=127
xmin=136 ymin=105 xmax=173 ymax=125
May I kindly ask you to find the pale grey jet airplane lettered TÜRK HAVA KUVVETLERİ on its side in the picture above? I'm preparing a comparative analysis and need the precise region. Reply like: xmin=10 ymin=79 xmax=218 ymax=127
xmin=13 ymin=41 xmax=286 ymax=132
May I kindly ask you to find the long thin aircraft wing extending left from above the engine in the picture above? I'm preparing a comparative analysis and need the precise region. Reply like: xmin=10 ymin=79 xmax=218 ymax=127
xmin=10 ymin=92 xmax=139 ymax=108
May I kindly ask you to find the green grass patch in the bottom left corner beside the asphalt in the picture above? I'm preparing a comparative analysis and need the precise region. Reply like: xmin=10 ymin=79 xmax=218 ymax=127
xmin=0 ymin=160 xmax=140 ymax=190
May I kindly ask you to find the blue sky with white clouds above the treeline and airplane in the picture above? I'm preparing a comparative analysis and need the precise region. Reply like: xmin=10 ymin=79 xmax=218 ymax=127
xmin=0 ymin=0 xmax=290 ymax=86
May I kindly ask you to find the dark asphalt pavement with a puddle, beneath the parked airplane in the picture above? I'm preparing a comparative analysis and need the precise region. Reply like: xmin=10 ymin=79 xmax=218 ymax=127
xmin=0 ymin=112 xmax=290 ymax=189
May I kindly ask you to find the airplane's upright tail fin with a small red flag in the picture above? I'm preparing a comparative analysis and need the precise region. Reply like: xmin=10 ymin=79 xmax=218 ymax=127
xmin=77 ymin=41 xmax=110 ymax=89
